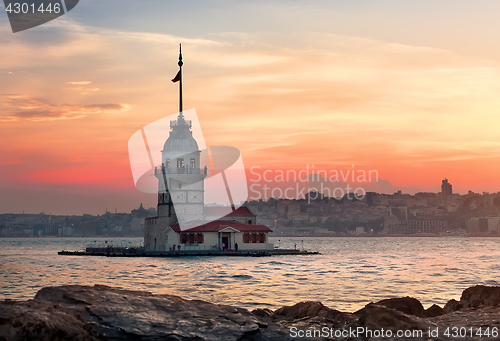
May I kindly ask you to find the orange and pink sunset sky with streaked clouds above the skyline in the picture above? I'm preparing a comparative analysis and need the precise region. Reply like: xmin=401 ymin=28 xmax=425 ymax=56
xmin=0 ymin=0 xmax=500 ymax=214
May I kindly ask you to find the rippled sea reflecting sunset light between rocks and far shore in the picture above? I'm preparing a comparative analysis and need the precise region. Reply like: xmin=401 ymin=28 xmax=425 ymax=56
xmin=0 ymin=237 xmax=500 ymax=311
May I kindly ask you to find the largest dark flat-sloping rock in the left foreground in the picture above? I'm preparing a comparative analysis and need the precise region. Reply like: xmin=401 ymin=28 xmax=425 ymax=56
xmin=0 ymin=286 xmax=290 ymax=341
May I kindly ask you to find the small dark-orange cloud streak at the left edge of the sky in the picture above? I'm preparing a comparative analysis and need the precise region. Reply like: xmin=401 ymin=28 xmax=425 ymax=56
xmin=0 ymin=95 xmax=131 ymax=122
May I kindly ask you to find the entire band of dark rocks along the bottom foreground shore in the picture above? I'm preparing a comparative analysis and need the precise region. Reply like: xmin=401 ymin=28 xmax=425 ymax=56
xmin=0 ymin=285 xmax=500 ymax=341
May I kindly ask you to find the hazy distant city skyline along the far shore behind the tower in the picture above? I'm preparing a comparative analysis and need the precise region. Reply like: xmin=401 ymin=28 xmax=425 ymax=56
xmin=0 ymin=179 xmax=500 ymax=238
